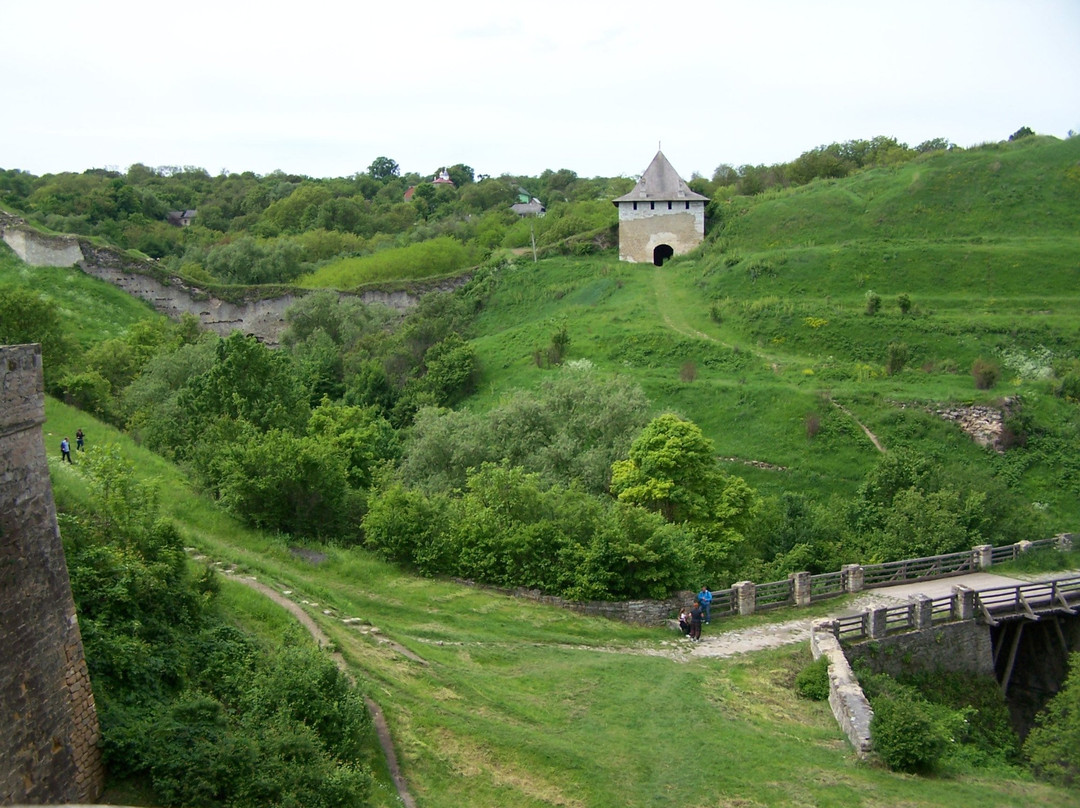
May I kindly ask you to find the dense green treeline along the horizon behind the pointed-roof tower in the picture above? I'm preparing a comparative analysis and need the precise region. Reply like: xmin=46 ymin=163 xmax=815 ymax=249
xmin=0 ymin=136 xmax=976 ymax=288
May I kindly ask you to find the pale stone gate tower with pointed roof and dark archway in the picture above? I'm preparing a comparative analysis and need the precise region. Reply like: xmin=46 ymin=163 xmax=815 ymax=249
xmin=612 ymin=151 xmax=708 ymax=267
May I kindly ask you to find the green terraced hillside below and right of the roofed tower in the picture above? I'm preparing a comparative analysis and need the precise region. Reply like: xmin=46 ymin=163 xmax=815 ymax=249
xmin=469 ymin=138 xmax=1080 ymax=520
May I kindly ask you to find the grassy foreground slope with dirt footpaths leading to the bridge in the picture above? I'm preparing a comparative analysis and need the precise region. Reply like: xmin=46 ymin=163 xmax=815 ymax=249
xmin=39 ymin=400 xmax=1076 ymax=808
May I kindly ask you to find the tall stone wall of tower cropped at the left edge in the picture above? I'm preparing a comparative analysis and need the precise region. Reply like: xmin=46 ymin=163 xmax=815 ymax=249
xmin=0 ymin=345 xmax=104 ymax=805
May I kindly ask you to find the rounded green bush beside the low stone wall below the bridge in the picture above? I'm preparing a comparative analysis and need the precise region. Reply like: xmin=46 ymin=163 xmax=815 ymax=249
xmin=870 ymin=692 xmax=948 ymax=772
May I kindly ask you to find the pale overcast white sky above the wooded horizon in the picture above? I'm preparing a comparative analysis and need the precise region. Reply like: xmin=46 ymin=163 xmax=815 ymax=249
xmin=0 ymin=0 xmax=1080 ymax=178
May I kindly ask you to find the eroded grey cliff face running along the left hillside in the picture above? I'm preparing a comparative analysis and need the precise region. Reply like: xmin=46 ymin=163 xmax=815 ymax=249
xmin=0 ymin=212 xmax=464 ymax=346
